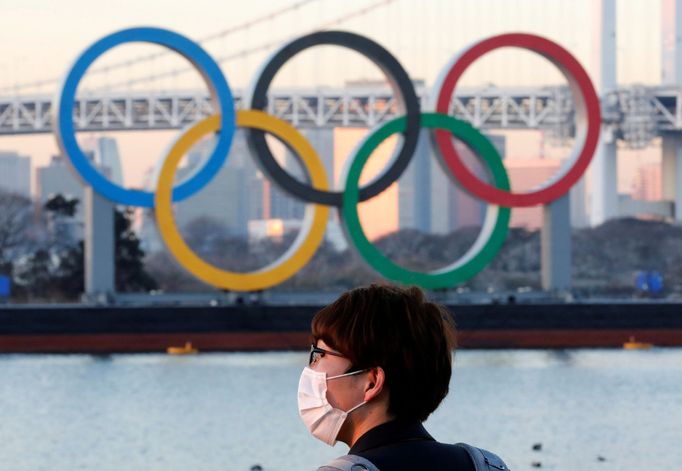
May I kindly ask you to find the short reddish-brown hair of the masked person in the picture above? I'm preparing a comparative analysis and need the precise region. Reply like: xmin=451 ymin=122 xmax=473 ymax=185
xmin=312 ymin=284 xmax=456 ymax=421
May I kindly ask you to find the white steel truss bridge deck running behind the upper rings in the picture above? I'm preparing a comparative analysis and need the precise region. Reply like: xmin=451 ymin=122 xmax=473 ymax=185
xmin=0 ymin=86 xmax=682 ymax=148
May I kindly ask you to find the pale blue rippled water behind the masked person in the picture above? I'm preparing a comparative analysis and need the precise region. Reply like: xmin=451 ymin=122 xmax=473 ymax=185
xmin=0 ymin=349 xmax=682 ymax=471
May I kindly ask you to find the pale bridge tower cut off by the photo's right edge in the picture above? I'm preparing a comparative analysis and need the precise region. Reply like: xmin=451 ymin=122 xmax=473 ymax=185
xmin=661 ymin=0 xmax=682 ymax=223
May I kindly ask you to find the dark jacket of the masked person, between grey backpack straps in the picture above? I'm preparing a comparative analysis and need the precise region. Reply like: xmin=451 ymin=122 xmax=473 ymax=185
xmin=348 ymin=420 xmax=475 ymax=471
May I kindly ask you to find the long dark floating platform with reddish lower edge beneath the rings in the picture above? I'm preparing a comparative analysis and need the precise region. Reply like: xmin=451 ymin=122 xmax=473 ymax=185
xmin=0 ymin=303 xmax=682 ymax=353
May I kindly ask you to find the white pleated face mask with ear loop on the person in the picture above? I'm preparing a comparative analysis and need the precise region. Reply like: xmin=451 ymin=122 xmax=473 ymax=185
xmin=298 ymin=367 xmax=366 ymax=446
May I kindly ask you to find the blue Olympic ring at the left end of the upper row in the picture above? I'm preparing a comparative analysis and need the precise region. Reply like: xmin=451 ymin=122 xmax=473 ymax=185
xmin=53 ymin=28 xmax=236 ymax=208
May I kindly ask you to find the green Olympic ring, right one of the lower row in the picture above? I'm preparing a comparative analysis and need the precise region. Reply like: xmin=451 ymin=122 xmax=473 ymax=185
xmin=341 ymin=113 xmax=511 ymax=289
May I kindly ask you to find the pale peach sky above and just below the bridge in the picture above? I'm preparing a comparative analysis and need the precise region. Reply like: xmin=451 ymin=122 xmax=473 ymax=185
xmin=0 ymin=0 xmax=661 ymax=236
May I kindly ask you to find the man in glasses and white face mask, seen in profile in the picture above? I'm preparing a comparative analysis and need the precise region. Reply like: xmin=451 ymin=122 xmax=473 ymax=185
xmin=298 ymin=285 xmax=504 ymax=471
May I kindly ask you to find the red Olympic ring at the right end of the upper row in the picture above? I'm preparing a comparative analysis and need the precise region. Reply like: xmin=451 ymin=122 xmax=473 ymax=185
xmin=435 ymin=33 xmax=601 ymax=207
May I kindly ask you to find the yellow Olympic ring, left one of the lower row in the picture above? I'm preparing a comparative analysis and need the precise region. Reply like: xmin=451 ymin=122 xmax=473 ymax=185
xmin=154 ymin=110 xmax=329 ymax=291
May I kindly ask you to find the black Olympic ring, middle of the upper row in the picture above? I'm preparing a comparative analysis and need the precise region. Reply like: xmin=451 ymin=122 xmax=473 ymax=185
xmin=246 ymin=31 xmax=420 ymax=207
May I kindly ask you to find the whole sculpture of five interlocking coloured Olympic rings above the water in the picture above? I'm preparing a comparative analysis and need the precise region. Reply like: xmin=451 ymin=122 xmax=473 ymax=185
xmin=53 ymin=28 xmax=601 ymax=291
